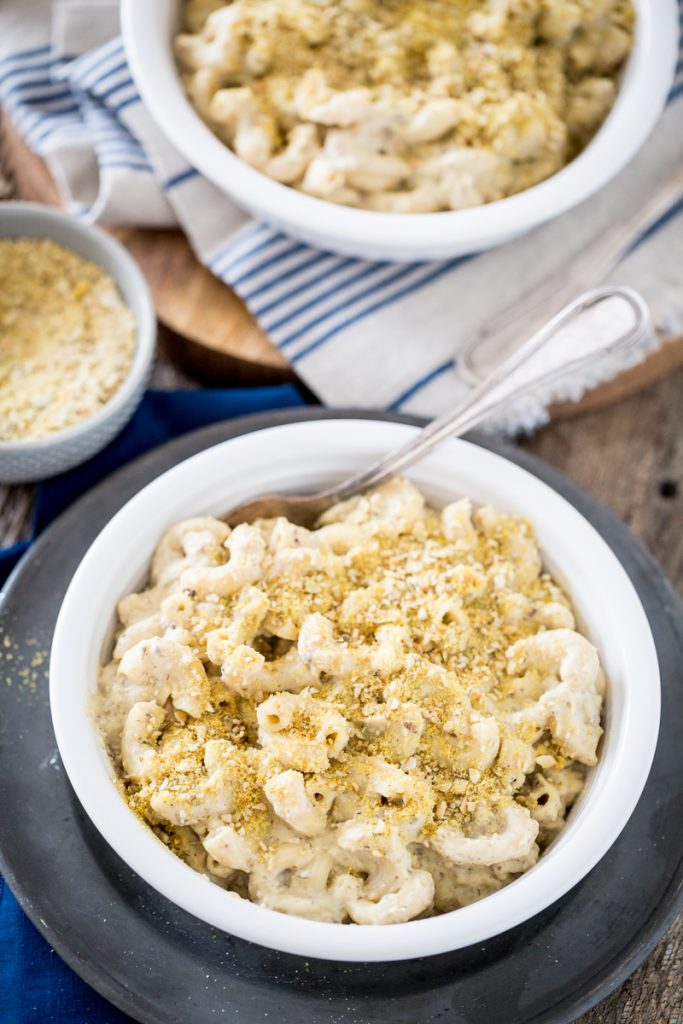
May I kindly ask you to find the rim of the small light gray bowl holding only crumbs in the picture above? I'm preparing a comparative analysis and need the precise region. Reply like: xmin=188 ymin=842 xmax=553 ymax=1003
xmin=0 ymin=200 xmax=157 ymax=456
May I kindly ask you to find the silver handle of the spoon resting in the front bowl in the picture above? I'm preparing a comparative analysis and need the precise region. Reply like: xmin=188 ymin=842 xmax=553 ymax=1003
xmin=321 ymin=286 xmax=650 ymax=504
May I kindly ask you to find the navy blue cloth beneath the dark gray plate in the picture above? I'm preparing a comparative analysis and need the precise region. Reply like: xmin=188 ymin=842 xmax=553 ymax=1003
xmin=0 ymin=385 xmax=305 ymax=1024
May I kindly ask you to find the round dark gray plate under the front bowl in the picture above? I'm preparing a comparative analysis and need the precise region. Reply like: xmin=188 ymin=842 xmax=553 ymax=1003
xmin=0 ymin=411 xmax=683 ymax=1024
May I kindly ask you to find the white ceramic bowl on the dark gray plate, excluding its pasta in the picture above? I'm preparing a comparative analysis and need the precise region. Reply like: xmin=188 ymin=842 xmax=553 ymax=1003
xmin=50 ymin=420 xmax=659 ymax=961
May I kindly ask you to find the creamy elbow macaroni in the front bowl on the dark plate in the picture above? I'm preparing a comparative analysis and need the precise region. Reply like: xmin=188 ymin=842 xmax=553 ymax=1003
xmin=95 ymin=479 xmax=604 ymax=925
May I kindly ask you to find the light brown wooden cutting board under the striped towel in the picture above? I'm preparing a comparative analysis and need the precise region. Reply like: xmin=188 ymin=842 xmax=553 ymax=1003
xmin=5 ymin=110 xmax=683 ymax=420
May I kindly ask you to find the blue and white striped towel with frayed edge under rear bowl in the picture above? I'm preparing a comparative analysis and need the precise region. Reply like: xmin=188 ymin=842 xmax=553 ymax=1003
xmin=0 ymin=0 xmax=683 ymax=429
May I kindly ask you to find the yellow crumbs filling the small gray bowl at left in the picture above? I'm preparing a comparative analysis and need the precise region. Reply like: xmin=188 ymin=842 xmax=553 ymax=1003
xmin=0 ymin=238 xmax=135 ymax=441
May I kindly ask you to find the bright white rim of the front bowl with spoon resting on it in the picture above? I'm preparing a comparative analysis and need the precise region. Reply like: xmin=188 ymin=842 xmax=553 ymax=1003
xmin=50 ymin=419 xmax=659 ymax=962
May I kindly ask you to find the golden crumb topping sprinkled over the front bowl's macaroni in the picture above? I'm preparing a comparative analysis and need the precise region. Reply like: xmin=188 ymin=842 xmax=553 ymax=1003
xmin=116 ymin=495 xmax=581 ymax=855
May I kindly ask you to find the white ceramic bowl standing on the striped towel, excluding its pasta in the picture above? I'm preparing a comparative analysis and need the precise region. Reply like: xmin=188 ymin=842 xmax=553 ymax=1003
xmin=121 ymin=0 xmax=679 ymax=260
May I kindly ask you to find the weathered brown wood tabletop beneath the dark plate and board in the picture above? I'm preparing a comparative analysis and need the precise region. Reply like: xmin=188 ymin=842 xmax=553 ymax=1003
xmin=0 ymin=105 xmax=683 ymax=1024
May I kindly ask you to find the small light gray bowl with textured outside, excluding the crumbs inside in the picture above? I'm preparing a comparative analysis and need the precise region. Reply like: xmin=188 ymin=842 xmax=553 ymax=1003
xmin=0 ymin=203 xmax=157 ymax=483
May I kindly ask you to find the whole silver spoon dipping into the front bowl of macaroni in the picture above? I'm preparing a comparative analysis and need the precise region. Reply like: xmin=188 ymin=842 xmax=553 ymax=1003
xmin=223 ymin=286 xmax=650 ymax=526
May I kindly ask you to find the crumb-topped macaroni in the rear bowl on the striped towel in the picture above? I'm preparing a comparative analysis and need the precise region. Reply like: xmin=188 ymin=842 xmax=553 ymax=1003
xmin=175 ymin=0 xmax=634 ymax=213
